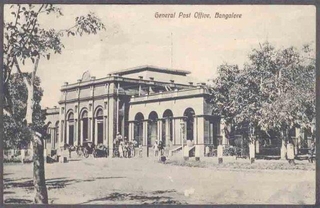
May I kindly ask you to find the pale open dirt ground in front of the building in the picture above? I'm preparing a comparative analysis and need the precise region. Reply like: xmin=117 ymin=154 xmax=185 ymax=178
xmin=4 ymin=158 xmax=315 ymax=204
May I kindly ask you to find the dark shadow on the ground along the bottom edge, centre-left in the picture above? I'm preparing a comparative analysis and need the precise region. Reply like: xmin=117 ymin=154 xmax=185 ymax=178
xmin=84 ymin=190 xmax=186 ymax=205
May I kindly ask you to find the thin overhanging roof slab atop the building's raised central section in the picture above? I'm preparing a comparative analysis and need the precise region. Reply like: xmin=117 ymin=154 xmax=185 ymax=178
xmin=110 ymin=65 xmax=191 ymax=76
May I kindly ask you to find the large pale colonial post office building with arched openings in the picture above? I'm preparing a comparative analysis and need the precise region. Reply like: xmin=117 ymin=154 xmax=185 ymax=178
xmin=46 ymin=66 xmax=227 ymax=156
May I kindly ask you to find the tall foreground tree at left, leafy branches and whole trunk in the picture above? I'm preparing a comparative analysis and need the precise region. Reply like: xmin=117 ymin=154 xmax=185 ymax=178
xmin=3 ymin=4 xmax=105 ymax=204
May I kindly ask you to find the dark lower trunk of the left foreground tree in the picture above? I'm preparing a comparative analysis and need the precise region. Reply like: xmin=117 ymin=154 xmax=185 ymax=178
xmin=32 ymin=132 xmax=48 ymax=204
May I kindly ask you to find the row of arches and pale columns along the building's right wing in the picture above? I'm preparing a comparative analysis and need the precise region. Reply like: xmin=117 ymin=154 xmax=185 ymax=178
xmin=129 ymin=108 xmax=227 ymax=157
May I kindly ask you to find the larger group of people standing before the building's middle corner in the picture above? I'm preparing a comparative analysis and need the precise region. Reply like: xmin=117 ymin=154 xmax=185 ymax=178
xmin=113 ymin=132 xmax=135 ymax=158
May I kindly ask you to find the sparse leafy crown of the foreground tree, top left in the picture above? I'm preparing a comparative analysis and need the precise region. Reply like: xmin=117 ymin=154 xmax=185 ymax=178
xmin=3 ymin=4 xmax=105 ymax=113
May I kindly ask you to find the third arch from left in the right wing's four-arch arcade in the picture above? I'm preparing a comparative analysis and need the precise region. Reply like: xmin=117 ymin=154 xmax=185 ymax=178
xmin=162 ymin=109 xmax=173 ymax=146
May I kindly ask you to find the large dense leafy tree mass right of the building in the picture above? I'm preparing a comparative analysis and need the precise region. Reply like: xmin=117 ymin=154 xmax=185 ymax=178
xmin=211 ymin=42 xmax=315 ymax=157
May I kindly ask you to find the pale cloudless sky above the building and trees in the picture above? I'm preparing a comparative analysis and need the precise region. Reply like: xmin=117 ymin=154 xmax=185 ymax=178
xmin=5 ymin=5 xmax=316 ymax=107
